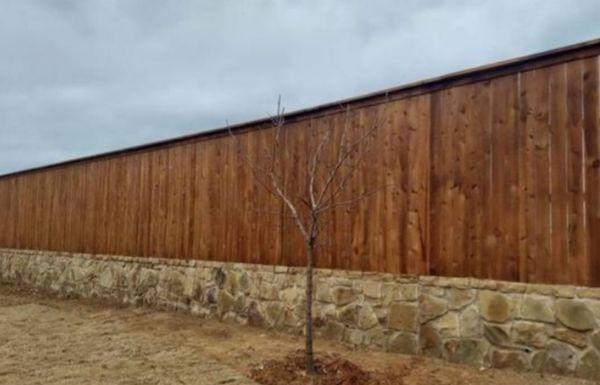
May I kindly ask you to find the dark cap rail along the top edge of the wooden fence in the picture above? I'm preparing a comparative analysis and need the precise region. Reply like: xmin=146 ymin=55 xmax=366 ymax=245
xmin=0 ymin=38 xmax=600 ymax=179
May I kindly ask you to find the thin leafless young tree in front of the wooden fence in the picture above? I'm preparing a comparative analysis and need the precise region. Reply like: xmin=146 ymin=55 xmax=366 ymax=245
xmin=228 ymin=96 xmax=381 ymax=374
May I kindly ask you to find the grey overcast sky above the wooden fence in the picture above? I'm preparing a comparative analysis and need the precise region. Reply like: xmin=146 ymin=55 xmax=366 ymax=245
xmin=0 ymin=0 xmax=600 ymax=174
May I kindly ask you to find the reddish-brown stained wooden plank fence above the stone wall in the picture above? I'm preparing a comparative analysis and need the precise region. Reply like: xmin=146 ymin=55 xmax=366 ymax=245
xmin=0 ymin=40 xmax=600 ymax=286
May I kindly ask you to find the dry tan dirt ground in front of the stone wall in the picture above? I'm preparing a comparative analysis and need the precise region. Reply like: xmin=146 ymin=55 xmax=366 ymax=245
xmin=0 ymin=285 xmax=592 ymax=385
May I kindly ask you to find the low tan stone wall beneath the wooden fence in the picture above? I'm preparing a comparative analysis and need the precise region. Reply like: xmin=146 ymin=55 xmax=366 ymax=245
xmin=0 ymin=249 xmax=600 ymax=379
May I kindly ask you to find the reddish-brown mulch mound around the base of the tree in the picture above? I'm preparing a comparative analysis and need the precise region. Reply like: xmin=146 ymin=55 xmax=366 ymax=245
xmin=250 ymin=350 xmax=409 ymax=385
